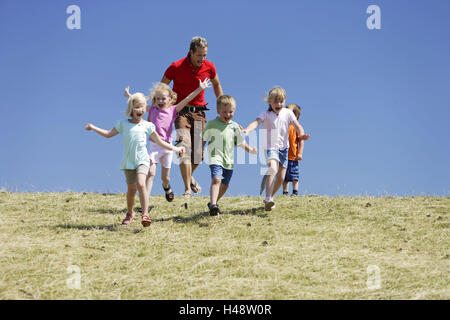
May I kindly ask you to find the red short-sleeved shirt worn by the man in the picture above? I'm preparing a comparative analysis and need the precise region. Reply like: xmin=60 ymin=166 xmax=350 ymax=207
xmin=164 ymin=55 xmax=216 ymax=106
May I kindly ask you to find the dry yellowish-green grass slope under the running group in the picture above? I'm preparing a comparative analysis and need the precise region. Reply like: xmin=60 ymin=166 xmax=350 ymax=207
xmin=0 ymin=192 xmax=450 ymax=299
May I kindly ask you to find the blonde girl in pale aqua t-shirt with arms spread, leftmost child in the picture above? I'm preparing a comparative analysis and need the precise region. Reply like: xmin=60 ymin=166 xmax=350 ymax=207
xmin=85 ymin=92 xmax=184 ymax=227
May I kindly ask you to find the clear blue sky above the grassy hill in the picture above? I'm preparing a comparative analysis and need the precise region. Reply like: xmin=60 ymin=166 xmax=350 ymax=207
xmin=0 ymin=0 xmax=450 ymax=196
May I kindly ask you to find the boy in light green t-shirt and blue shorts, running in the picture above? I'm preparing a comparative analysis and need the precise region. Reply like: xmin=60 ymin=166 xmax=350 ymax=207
xmin=202 ymin=95 xmax=258 ymax=216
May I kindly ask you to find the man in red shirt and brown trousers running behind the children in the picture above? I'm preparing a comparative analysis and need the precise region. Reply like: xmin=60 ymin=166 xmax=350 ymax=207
xmin=161 ymin=37 xmax=223 ymax=196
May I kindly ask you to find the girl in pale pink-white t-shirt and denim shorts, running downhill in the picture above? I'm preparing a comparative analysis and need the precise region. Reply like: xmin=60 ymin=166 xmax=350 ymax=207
xmin=244 ymin=87 xmax=309 ymax=211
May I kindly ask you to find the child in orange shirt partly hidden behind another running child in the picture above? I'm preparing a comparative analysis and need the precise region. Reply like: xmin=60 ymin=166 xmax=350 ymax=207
xmin=283 ymin=104 xmax=303 ymax=196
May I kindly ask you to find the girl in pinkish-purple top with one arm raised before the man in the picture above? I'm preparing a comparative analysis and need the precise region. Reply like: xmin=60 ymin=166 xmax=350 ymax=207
xmin=124 ymin=78 xmax=211 ymax=202
